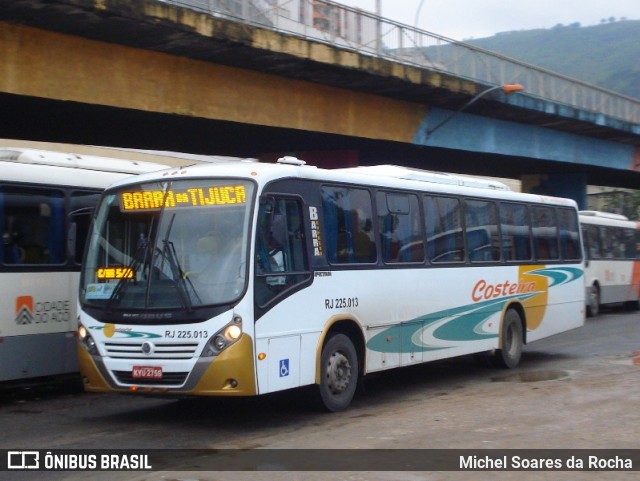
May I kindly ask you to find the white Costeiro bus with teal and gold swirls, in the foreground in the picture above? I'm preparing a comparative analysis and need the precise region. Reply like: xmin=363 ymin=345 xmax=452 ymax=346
xmin=78 ymin=158 xmax=585 ymax=411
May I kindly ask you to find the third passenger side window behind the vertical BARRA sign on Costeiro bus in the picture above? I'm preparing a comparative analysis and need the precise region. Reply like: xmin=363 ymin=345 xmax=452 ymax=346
xmin=424 ymin=196 xmax=465 ymax=262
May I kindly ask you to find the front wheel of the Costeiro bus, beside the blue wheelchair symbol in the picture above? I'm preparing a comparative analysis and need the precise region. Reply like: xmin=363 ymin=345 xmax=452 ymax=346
xmin=318 ymin=334 xmax=359 ymax=412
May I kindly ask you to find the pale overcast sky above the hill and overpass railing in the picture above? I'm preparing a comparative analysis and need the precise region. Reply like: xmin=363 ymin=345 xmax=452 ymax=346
xmin=334 ymin=0 xmax=640 ymax=40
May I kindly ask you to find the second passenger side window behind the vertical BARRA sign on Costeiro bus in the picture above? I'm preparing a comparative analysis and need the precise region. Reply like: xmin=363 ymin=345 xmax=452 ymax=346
xmin=376 ymin=192 xmax=424 ymax=263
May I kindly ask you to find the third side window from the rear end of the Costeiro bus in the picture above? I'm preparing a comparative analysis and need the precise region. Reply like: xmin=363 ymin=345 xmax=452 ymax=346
xmin=500 ymin=203 xmax=531 ymax=261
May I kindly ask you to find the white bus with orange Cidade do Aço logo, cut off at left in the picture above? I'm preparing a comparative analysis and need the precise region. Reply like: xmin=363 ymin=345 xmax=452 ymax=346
xmin=0 ymin=147 xmax=165 ymax=382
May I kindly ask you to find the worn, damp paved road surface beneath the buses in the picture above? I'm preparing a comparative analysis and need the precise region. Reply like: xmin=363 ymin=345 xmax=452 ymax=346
xmin=0 ymin=310 xmax=640 ymax=481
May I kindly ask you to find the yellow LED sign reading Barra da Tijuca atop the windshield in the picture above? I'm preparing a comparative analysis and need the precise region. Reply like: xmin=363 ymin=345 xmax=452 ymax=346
xmin=120 ymin=185 xmax=247 ymax=212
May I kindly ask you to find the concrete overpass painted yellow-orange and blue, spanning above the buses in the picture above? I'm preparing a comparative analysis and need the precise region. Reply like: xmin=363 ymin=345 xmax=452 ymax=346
xmin=0 ymin=0 xmax=640 ymax=204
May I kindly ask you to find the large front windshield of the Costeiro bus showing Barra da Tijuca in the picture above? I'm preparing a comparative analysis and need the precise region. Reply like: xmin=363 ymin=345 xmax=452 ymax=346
xmin=80 ymin=179 xmax=254 ymax=311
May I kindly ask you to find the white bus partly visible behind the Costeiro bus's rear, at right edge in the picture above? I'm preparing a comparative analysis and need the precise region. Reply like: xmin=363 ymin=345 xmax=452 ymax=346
xmin=580 ymin=211 xmax=640 ymax=316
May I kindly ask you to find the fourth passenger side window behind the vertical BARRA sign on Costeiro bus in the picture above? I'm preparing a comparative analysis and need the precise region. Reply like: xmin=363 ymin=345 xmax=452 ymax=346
xmin=465 ymin=200 xmax=500 ymax=262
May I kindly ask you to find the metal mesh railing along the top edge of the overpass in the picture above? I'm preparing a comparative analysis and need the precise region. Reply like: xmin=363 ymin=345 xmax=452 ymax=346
xmin=159 ymin=0 xmax=640 ymax=126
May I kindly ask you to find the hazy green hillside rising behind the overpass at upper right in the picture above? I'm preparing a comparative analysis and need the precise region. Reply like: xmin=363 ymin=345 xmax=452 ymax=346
xmin=465 ymin=20 xmax=640 ymax=99
